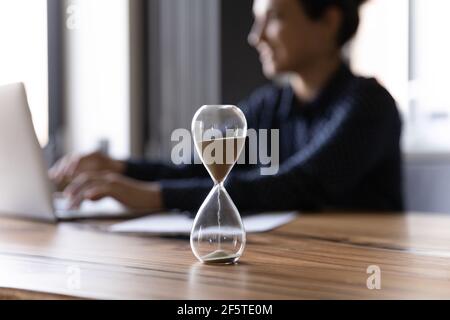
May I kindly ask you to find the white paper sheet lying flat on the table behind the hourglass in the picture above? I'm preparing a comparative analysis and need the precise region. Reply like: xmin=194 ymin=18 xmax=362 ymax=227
xmin=108 ymin=212 xmax=297 ymax=235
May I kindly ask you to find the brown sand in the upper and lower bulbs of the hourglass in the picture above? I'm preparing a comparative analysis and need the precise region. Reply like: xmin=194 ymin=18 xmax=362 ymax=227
xmin=198 ymin=137 xmax=245 ymax=264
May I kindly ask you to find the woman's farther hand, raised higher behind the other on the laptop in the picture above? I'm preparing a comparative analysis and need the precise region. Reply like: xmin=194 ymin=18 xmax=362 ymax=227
xmin=49 ymin=152 xmax=125 ymax=190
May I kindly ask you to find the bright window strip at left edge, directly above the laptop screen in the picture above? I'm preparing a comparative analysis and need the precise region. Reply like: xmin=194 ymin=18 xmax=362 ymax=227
xmin=0 ymin=0 xmax=48 ymax=146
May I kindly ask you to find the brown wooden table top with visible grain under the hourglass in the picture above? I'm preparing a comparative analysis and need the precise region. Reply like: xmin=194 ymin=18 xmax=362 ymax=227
xmin=0 ymin=213 xmax=450 ymax=299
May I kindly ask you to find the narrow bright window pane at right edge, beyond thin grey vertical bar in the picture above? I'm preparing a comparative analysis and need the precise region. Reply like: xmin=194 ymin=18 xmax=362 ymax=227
xmin=409 ymin=0 xmax=450 ymax=152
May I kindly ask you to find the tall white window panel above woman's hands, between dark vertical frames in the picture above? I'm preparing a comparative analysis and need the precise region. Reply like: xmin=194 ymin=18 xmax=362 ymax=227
xmin=64 ymin=0 xmax=131 ymax=157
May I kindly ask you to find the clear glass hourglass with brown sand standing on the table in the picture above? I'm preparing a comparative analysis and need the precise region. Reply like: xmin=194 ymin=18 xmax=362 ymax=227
xmin=191 ymin=105 xmax=247 ymax=264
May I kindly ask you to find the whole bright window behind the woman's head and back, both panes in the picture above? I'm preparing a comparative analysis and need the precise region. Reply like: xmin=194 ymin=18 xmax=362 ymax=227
xmin=351 ymin=0 xmax=450 ymax=153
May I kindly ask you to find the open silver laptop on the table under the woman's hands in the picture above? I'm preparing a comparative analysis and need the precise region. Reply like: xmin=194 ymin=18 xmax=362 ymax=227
xmin=0 ymin=83 xmax=142 ymax=222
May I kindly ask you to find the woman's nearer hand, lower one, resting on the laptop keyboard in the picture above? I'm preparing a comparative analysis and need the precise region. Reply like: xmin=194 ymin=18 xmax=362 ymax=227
xmin=64 ymin=172 xmax=163 ymax=211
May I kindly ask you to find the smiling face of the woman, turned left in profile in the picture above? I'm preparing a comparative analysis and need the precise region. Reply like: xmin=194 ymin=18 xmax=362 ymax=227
xmin=248 ymin=0 xmax=338 ymax=78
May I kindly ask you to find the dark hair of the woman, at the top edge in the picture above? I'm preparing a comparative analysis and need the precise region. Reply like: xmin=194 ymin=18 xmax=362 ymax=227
xmin=298 ymin=0 xmax=366 ymax=47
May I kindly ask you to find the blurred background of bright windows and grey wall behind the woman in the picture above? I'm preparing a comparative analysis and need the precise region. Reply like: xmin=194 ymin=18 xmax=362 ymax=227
xmin=0 ymin=0 xmax=450 ymax=213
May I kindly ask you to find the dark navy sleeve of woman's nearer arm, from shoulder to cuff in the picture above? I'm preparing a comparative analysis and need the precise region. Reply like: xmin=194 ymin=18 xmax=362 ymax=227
xmin=162 ymin=80 xmax=401 ymax=211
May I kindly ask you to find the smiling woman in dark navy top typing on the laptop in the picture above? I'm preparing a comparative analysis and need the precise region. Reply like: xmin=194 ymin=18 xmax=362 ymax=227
xmin=50 ymin=0 xmax=403 ymax=211
